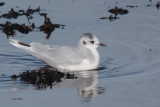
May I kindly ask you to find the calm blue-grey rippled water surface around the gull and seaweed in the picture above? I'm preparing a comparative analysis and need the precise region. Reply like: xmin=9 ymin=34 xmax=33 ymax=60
xmin=0 ymin=0 xmax=160 ymax=107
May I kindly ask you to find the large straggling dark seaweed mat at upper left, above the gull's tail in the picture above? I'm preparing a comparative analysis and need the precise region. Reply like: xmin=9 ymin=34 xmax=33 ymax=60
xmin=0 ymin=7 xmax=65 ymax=39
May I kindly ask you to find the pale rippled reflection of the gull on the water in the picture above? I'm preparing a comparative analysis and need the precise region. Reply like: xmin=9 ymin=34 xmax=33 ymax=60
xmin=54 ymin=70 xmax=105 ymax=102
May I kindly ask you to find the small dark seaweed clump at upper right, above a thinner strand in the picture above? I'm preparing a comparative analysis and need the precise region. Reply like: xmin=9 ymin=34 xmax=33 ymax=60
xmin=108 ymin=6 xmax=129 ymax=16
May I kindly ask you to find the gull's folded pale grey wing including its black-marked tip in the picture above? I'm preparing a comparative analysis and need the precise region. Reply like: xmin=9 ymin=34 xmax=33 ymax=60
xmin=10 ymin=39 xmax=85 ymax=68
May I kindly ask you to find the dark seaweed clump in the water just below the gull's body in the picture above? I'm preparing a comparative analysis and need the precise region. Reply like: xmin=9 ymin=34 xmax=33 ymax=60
xmin=11 ymin=66 xmax=77 ymax=89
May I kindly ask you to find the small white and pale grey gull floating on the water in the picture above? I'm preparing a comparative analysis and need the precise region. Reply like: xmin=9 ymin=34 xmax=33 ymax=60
xmin=10 ymin=33 xmax=106 ymax=71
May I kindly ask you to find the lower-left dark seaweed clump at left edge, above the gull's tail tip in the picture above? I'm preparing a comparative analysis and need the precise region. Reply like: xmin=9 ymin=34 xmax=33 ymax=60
xmin=0 ymin=21 xmax=31 ymax=38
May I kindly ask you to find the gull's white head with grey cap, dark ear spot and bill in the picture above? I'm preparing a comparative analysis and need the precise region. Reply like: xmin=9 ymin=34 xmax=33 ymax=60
xmin=79 ymin=33 xmax=106 ymax=49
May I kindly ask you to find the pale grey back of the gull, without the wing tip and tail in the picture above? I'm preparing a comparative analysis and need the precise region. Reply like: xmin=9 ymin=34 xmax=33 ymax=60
xmin=27 ymin=42 xmax=91 ymax=67
